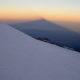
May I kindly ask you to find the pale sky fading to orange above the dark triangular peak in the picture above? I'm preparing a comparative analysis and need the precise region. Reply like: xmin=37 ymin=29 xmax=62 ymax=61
xmin=0 ymin=0 xmax=80 ymax=32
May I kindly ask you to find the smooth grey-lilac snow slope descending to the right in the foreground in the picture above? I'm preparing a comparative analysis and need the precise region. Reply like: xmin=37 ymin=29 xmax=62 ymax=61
xmin=0 ymin=22 xmax=80 ymax=80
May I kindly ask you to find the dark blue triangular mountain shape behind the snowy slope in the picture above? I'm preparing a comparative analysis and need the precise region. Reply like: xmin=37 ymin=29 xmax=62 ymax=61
xmin=12 ymin=19 xmax=80 ymax=50
